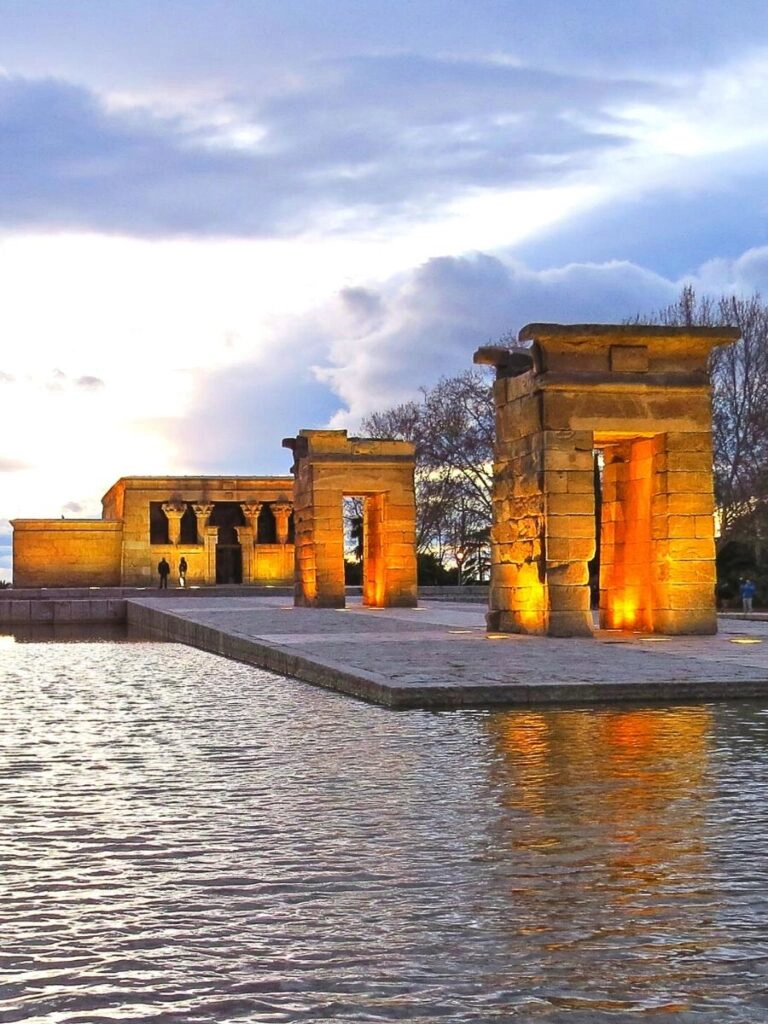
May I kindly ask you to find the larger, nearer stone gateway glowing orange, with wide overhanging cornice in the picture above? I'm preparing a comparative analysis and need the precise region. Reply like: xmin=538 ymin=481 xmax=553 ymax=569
xmin=475 ymin=324 xmax=738 ymax=636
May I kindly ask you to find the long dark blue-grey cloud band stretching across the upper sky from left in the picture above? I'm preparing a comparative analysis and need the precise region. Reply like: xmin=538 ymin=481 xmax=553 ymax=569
xmin=0 ymin=55 xmax=657 ymax=236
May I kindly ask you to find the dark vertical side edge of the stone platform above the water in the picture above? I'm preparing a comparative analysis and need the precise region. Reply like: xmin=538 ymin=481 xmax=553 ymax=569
xmin=127 ymin=601 xmax=768 ymax=711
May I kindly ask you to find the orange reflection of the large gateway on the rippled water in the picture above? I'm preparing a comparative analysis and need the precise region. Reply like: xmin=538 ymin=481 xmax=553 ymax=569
xmin=484 ymin=706 xmax=721 ymax=983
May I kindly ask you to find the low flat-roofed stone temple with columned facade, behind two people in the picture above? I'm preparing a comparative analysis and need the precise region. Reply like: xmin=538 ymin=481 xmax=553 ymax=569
xmin=12 ymin=476 xmax=294 ymax=587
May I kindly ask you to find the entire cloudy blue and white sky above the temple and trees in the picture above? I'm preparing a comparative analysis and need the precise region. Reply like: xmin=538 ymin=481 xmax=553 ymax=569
xmin=0 ymin=0 xmax=768 ymax=579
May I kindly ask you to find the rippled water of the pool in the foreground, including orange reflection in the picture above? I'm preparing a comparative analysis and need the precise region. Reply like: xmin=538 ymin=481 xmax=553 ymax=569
xmin=0 ymin=637 xmax=768 ymax=1024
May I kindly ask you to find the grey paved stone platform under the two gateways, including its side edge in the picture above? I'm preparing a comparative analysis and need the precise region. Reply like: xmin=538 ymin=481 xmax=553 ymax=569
xmin=128 ymin=597 xmax=768 ymax=708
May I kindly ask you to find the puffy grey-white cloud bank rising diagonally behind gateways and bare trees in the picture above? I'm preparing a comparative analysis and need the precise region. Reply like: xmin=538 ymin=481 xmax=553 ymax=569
xmin=173 ymin=253 xmax=679 ymax=473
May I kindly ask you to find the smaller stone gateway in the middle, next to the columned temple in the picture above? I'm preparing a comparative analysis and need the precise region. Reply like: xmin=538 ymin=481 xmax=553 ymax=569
xmin=283 ymin=430 xmax=417 ymax=608
